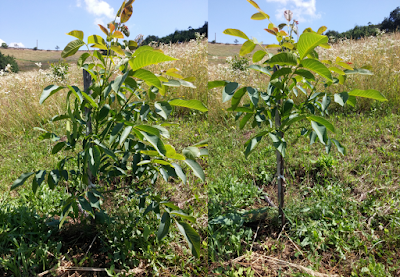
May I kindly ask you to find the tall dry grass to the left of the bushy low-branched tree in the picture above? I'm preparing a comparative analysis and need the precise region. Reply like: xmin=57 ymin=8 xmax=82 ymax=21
xmin=0 ymin=65 xmax=83 ymax=137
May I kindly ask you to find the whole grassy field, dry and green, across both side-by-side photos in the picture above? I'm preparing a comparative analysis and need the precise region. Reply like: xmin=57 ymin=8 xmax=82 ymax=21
xmin=0 ymin=29 xmax=400 ymax=277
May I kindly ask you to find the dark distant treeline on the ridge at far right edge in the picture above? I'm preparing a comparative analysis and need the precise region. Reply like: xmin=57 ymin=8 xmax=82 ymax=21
xmin=325 ymin=7 xmax=400 ymax=40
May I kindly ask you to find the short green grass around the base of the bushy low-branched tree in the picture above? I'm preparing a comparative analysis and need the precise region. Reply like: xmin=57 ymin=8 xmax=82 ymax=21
xmin=0 ymin=115 xmax=208 ymax=276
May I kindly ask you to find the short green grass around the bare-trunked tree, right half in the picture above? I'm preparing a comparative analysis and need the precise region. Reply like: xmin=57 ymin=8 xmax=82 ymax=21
xmin=209 ymin=109 xmax=400 ymax=276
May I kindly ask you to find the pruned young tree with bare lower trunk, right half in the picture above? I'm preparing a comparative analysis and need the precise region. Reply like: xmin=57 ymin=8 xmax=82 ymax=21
xmin=208 ymin=0 xmax=387 ymax=226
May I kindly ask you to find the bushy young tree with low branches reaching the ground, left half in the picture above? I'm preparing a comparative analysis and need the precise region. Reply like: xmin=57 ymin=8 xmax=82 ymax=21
xmin=11 ymin=0 xmax=208 ymax=257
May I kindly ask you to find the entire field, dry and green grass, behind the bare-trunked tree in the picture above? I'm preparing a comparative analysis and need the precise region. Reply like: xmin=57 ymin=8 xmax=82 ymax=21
xmin=208 ymin=33 xmax=400 ymax=276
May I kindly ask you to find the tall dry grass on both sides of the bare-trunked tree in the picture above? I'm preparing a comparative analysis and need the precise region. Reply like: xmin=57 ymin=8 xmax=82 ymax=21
xmin=208 ymin=32 xmax=400 ymax=120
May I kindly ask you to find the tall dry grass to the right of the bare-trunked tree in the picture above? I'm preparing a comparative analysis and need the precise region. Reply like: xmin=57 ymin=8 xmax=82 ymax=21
xmin=319 ymin=32 xmax=400 ymax=112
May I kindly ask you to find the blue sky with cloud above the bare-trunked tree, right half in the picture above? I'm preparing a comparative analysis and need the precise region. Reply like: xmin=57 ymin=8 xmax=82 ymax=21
xmin=208 ymin=0 xmax=400 ymax=43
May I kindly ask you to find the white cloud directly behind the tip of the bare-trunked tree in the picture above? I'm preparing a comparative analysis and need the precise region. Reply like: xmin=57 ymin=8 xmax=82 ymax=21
xmin=266 ymin=0 xmax=321 ymax=23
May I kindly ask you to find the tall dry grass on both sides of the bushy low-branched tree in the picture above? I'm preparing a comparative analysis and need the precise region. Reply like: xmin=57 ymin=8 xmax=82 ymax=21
xmin=0 ymin=36 xmax=208 ymax=138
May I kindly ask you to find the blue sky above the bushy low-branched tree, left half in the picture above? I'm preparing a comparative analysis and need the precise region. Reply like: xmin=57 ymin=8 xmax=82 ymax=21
xmin=0 ymin=0 xmax=208 ymax=50
